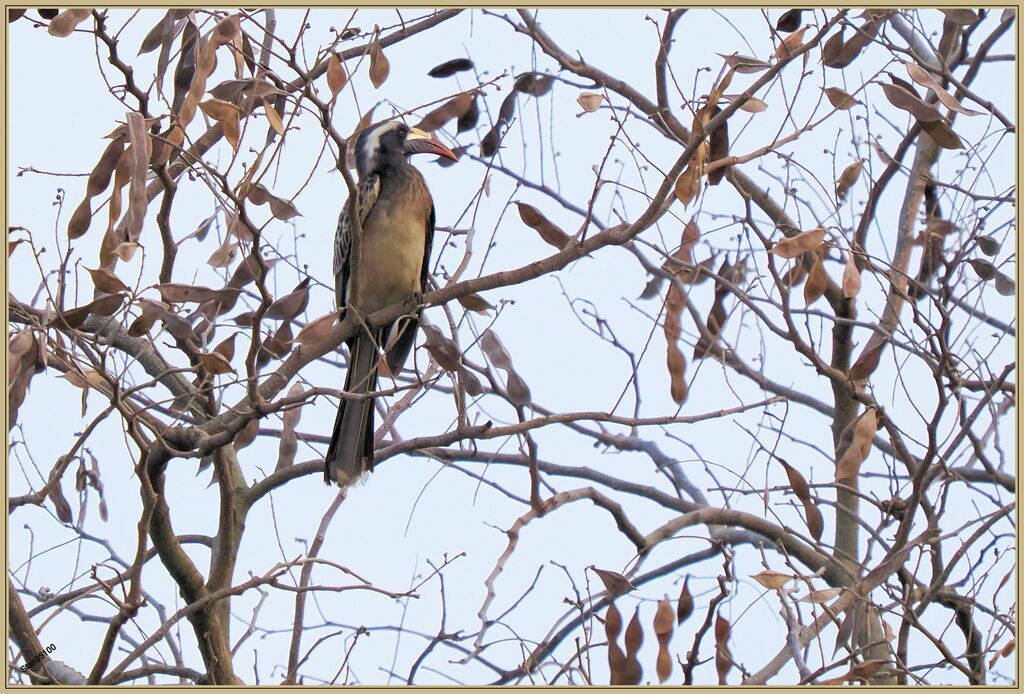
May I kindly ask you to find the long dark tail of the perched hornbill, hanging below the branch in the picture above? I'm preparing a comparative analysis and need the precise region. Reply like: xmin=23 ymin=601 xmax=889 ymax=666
xmin=324 ymin=331 xmax=383 ymax=486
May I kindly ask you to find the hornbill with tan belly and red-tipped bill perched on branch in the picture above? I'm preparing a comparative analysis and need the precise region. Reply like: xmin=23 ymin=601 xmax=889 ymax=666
xmin=324 ymin=121 xmax=458 ymax=487
